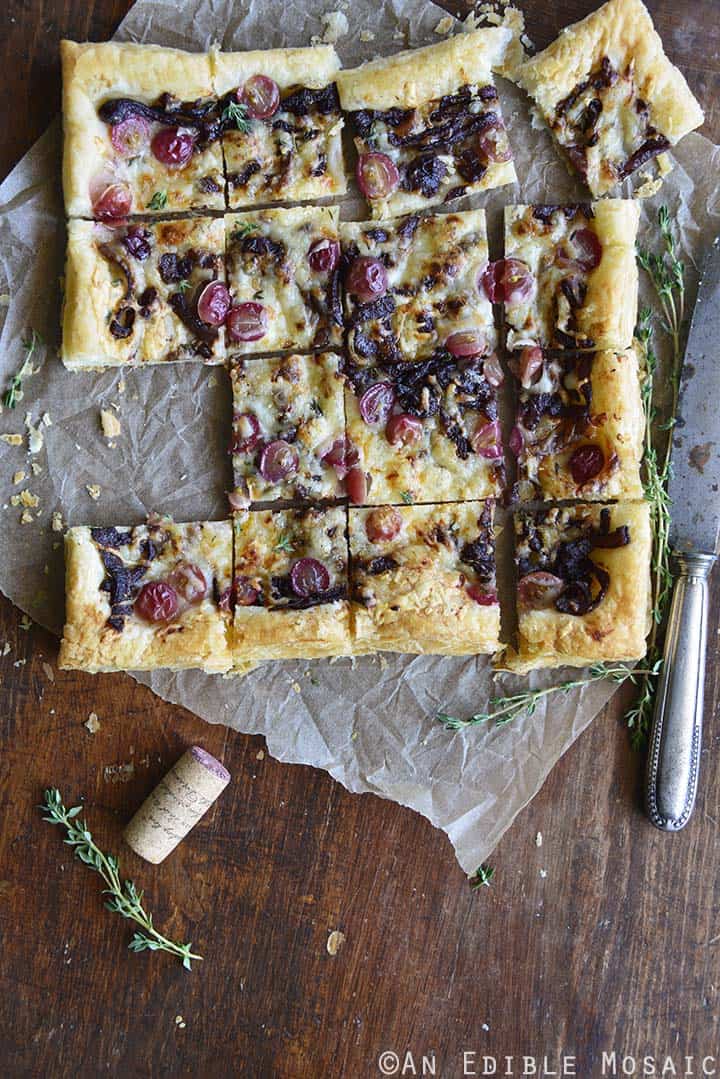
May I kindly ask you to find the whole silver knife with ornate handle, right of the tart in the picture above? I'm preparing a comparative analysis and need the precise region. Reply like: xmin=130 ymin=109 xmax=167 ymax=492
xmin=646 ymin=236 xmax=720 ymax=832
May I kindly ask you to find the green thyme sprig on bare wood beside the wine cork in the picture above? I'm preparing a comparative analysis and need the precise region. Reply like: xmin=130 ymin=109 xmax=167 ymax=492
xmin=40 ymin=787 xmax=202 ymax=970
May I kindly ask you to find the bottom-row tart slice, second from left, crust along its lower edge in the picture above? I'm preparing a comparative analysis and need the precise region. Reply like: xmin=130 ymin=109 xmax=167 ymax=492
xmin=233 ymin=507 xmax=352 ymax=664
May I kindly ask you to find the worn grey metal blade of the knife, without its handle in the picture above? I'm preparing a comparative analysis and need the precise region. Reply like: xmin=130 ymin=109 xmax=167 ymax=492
xmin=668 ymin=236 xmax=720 ymax=555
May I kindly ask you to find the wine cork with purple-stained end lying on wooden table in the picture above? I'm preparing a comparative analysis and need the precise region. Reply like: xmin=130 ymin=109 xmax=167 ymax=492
xmin=123 ymin=746 xmax=230 ymax=865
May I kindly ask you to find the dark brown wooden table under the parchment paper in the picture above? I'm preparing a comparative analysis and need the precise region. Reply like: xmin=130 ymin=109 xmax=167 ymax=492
xmin=0 ymin=0 xmax=720 ymax=1079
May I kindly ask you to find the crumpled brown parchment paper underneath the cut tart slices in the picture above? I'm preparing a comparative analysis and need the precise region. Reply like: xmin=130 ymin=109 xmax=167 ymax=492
xmin=0 ymin=0 xmax=720 ymax=873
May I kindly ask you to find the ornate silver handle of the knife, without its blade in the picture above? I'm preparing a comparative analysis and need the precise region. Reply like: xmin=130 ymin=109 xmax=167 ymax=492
xmin=646 ymin=555 xmax=715 ymax=832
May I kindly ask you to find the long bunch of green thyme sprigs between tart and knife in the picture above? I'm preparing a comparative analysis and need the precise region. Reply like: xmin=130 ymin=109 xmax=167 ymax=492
xmin=436 ymin=206 xmax=685 ymax=749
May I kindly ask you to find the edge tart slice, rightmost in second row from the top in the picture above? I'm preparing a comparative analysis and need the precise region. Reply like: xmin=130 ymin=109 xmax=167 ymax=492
xmin=500 ymin=199 xmax=640 ymax=350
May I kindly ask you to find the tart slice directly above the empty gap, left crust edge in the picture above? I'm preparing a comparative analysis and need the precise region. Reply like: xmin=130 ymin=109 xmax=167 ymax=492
xmin=62 ymin=217 xmax=230 ymax=369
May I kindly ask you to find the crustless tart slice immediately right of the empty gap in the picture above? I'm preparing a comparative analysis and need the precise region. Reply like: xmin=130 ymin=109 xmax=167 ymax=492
xmin=231 ymin=353 xmax=347 ymax=508
